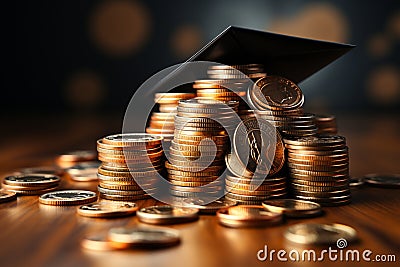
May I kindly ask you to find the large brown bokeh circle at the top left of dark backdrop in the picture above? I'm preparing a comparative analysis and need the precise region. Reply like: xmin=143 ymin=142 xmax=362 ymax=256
xmin=89 ymin=0 xmax=151 ymax=56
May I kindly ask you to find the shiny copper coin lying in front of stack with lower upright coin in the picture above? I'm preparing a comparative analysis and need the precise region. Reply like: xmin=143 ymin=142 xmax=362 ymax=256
xmin=217 ymin=205 xmax=282 ymax=227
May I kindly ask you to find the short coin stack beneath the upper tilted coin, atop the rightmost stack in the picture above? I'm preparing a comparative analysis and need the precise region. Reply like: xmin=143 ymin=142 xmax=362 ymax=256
xmin=254 ymin=112 xmax=317 ymax=137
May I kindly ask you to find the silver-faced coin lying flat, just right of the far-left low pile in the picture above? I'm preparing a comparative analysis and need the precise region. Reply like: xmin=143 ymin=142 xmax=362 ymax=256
xmin=39 ymin=190 xmax=97 ymax=206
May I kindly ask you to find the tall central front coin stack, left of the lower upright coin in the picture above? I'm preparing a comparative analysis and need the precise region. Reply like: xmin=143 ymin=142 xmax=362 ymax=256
xmin=166 ymin=98 xmax=239 ymax=200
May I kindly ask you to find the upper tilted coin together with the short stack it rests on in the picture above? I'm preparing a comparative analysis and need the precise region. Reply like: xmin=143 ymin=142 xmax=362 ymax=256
xmin=248 ymin=76 xmax=317 ymax=136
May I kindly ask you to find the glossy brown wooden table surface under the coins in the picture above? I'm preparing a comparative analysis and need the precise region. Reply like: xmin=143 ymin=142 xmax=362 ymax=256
xmin=0 ymin=116 xmax=400 ymax=267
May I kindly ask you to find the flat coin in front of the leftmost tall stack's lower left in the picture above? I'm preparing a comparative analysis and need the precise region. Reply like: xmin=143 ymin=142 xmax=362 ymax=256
xmin=77 ymin=201 xmax=139 ymax=218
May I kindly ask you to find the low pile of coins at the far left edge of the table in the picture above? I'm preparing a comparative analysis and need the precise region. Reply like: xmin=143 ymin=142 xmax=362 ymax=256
xmin=2 ymin=174 xmax=60 ymax=195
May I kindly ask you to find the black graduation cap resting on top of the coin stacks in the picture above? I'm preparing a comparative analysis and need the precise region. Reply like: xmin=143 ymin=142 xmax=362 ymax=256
xmin=187 ymin=26 xmax=355 ymax=83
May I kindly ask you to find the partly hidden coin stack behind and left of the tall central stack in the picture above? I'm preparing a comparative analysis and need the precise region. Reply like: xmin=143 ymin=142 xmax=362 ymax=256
xmin=146 ymin=93 xmax=196 ymax=146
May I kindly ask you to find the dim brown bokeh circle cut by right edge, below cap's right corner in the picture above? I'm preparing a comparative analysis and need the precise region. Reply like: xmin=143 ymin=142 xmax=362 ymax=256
xmin=367 ymin=66 xmax=400 ymax=105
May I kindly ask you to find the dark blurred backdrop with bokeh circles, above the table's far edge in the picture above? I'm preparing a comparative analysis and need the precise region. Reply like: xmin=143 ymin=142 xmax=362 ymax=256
xmin=10 ymin=0 xmax=400 ymax=116
